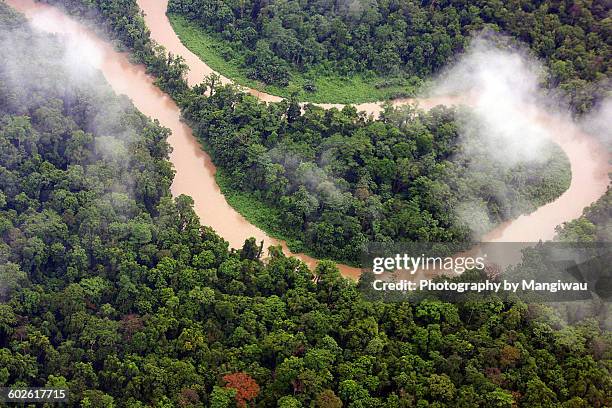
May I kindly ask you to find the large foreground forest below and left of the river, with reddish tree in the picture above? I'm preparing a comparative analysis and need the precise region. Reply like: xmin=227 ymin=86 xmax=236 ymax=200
xmin=0 ymin=4 xmax=612 ymax=408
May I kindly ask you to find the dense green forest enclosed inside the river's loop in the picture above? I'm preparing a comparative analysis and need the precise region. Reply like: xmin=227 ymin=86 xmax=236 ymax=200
xmin=183 ymin=82 xmax=571 ymax=262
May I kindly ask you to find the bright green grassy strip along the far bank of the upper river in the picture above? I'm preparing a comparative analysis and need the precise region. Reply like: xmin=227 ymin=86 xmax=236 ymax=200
xmin=168 ymin=13 xmax=420 ymax=103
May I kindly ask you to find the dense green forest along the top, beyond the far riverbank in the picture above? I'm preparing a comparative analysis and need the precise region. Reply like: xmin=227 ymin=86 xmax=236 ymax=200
xmin=168 ymin=0 xmax=612 ymax=113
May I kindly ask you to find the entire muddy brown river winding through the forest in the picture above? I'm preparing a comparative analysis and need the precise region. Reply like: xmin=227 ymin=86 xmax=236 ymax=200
xmin=5 ymin=0 xmax=611 ymax=278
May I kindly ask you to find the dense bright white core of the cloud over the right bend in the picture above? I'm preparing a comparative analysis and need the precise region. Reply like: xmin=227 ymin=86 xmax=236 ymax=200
xmin=434 ymin=37 xmax=550 ymax=167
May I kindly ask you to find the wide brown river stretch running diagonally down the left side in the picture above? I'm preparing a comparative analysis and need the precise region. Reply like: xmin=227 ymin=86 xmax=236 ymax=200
xmin=6 ymin=0 xmax=360 ymax=277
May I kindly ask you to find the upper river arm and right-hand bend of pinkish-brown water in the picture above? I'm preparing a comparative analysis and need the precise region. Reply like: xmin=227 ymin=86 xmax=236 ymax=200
xmin=131 ymin=0 xmax=611 ymax=242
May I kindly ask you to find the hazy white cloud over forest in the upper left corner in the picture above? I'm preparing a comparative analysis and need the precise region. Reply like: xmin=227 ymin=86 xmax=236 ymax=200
xmin=0 ymin=9 xmax=150 ymax=209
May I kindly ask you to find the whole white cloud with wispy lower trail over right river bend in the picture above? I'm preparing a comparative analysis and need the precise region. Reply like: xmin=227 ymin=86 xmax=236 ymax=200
xmin=432 ymin=34 xmax=571 ymax=239
